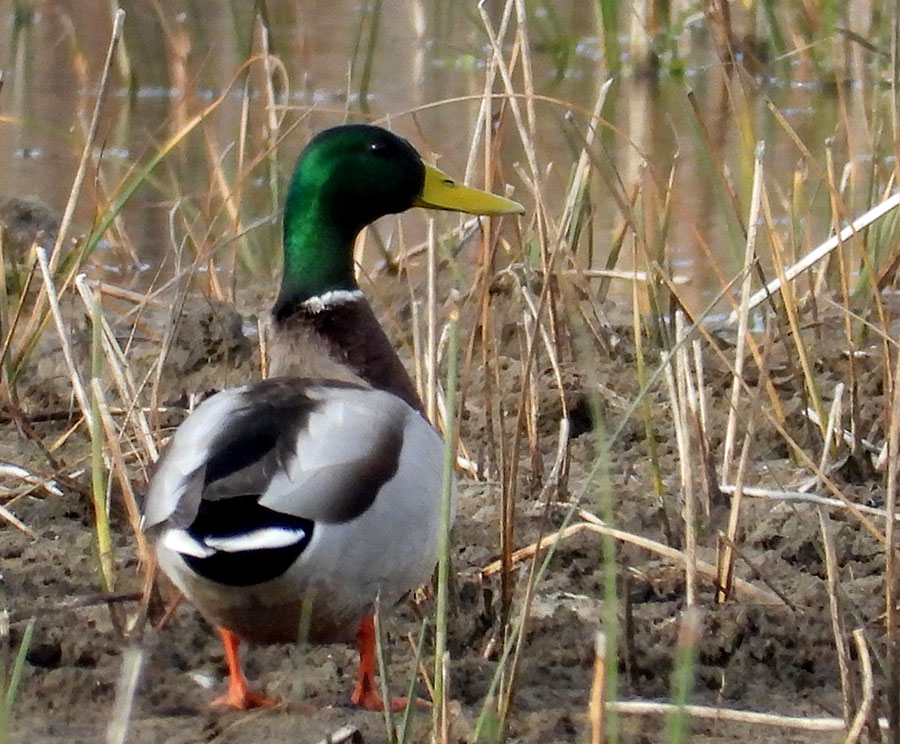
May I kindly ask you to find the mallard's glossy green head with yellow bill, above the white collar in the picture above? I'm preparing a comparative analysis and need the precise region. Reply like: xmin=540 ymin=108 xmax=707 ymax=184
xmin=275 ymin=124 xmax=525 ymax=315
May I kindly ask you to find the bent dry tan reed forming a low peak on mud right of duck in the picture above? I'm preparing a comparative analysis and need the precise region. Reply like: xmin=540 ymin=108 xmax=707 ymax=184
xmin=480 ymin=516 xmax=787 ymax=607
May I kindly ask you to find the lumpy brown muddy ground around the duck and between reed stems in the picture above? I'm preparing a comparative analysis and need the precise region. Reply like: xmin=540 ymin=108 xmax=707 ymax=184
xmin=0 ymin=270 xmax=884 ymax=744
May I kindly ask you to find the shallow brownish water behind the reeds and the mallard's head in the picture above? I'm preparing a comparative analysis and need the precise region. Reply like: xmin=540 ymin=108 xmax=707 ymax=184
xmin=0 ymin=0 xmax=893 ymax=310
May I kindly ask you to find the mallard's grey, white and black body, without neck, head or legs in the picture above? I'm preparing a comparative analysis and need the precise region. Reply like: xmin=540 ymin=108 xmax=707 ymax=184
xmin=145 ymin=378 xmax=443 ymax=642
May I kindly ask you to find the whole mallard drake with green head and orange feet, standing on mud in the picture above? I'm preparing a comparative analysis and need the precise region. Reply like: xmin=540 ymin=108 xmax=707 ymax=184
xmin=144 ymin=125 xmax=524 ymax=710
